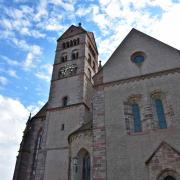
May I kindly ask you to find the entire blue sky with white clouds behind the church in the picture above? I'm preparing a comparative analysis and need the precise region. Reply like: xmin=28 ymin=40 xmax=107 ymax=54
xmin=0 ymin=0 xmax=180 ymax=180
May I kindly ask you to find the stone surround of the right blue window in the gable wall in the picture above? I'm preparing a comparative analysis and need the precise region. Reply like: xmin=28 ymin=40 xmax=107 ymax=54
xmin=150 ymin=89 xmax=173 ymax=129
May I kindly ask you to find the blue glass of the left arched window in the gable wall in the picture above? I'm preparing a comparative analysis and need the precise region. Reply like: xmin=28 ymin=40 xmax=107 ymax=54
xmin=132 ymin=103 xmax=142 ymax=132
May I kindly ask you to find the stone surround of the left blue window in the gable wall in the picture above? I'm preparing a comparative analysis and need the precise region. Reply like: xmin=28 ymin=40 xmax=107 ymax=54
xmin=124 ymin=94 xmax=143 ymax=134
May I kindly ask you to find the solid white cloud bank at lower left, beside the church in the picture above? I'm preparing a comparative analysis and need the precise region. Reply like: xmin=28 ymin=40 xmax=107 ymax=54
xmin=0 ymin=95 xmax=29 ymax=180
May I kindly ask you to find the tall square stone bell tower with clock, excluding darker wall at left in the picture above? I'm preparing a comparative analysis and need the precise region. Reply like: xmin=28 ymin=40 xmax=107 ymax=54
xmin=44 ymin=24 xmax=98 ymax=180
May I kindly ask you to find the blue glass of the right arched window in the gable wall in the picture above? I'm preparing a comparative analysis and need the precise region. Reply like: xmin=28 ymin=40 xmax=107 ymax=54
xmin=154 ymin=98 xmax=167 ymax=129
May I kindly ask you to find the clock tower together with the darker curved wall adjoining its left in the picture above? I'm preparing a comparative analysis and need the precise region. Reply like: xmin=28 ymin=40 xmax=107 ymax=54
xmin=13 ymin=23 xmax=98 ymax=180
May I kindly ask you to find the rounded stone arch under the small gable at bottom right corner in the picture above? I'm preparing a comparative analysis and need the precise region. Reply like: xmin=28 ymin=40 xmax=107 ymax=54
xmin=156 ymin=169 xmax=180 ymax=180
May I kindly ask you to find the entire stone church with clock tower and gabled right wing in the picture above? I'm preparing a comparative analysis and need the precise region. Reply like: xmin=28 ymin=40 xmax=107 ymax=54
xmin=13 ymin=24 xmax=180 ymax=180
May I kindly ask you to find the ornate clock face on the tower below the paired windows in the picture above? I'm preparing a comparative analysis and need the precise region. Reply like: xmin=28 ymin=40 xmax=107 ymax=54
xmin=59 ymin=64 xmax=77 ymax=78
